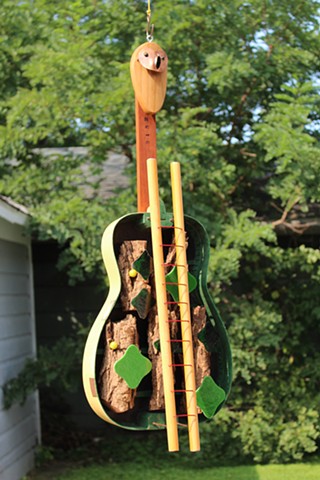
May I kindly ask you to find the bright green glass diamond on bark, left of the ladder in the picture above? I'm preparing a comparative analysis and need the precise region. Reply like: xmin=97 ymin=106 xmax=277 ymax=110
xmin=114 ymin=345 xmax=152 ymax=389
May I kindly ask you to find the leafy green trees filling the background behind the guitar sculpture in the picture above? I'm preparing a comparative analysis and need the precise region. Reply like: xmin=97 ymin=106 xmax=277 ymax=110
xmin=0 ymin=0 xmax=320 ymax=462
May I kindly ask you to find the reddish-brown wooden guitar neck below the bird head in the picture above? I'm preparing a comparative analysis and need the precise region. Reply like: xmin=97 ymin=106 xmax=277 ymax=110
xmin=135 ymin=99 xmax=157 ymax=212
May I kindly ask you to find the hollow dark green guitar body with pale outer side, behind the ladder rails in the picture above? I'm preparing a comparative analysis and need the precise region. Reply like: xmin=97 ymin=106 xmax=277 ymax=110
xmin=83 ymin=213 xmax=232 ymax=430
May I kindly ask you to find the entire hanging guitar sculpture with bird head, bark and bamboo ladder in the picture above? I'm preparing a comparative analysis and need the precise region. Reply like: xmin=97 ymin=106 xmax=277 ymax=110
xmin=83 ymin=8 xmax=232 ymax=451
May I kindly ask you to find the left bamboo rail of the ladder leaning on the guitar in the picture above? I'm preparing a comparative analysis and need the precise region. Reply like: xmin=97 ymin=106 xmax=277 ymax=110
xmin=147 ymin=158 xmax=179 ymax=452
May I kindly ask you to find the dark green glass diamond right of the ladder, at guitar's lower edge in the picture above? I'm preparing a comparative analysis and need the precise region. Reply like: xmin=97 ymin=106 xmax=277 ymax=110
xmin=196 ymin=376 xmax=226 ymax=418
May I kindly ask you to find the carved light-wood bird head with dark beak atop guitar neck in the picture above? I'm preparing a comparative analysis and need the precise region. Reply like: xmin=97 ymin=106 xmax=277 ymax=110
xmin=130 ymin=42 xmax=168 ymax=114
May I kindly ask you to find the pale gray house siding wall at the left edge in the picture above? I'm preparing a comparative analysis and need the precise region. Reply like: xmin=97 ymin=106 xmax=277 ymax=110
xmin=0 ymin=199 xmax=40 ymax=480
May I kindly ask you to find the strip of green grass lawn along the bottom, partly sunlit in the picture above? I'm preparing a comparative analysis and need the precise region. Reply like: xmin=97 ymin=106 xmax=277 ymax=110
xmin=28 ymin=459 xmax=320 ymax=480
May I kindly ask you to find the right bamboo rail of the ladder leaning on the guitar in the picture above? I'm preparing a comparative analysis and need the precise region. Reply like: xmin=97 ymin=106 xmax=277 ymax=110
xmin=170 ymin=162 xmax=200 ymax=452
